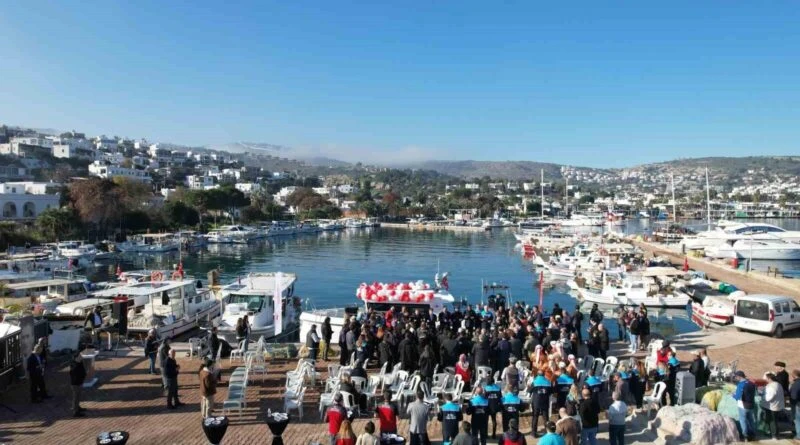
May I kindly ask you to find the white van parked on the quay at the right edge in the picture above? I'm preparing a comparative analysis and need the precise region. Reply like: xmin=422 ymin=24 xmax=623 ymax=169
xmin=733 ymin=294 xmax=800 ymax=338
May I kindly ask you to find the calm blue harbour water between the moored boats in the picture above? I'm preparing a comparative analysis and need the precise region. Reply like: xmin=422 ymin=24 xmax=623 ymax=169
xmin=93 ymin=228 xmax=708 ymax=335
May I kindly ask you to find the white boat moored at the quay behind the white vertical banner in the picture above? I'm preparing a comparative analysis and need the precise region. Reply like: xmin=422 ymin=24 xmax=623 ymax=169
xmin=217 ymin=272 xmax=303 ymax=344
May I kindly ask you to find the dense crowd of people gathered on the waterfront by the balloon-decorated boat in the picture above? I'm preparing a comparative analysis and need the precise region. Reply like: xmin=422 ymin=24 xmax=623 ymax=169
xmin=318 ymin=303 xmax=797 ymax=445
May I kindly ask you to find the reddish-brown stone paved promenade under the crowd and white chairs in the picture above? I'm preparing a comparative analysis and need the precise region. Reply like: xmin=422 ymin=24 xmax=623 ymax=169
xmin=0 ymin=331 xmax=800 ymax=445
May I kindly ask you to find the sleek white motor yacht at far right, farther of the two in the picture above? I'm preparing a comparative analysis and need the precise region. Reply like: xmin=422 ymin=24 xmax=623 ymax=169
xmin=681 ymin=221 xmax=800 ymax=249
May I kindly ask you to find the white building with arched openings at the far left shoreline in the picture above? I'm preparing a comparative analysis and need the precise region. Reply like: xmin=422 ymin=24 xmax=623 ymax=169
xmin=0 ymin=182 xmax=60 ymax=220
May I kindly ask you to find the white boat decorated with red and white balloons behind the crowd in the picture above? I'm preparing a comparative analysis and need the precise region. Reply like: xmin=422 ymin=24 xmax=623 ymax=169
xmin=300 ymin=274 xmax=455 ymax=340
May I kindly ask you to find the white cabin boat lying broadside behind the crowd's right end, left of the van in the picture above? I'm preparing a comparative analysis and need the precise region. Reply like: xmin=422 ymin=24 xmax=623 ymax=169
xmin=578 ymin=272 xmax=691 ymax=307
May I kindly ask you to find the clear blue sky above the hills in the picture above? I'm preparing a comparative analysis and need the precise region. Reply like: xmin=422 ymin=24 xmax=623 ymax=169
xmin=0 ymin=0 xmax=800 ymax=167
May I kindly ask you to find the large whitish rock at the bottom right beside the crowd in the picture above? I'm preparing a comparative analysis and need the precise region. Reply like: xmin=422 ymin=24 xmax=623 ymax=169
xmin=650 ymin=403 xmax=739 ymax=445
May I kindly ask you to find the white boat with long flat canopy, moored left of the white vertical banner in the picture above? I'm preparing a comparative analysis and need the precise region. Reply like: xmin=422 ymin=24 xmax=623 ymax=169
xmin=95 ymin=279 xmax=220 ymax=338
